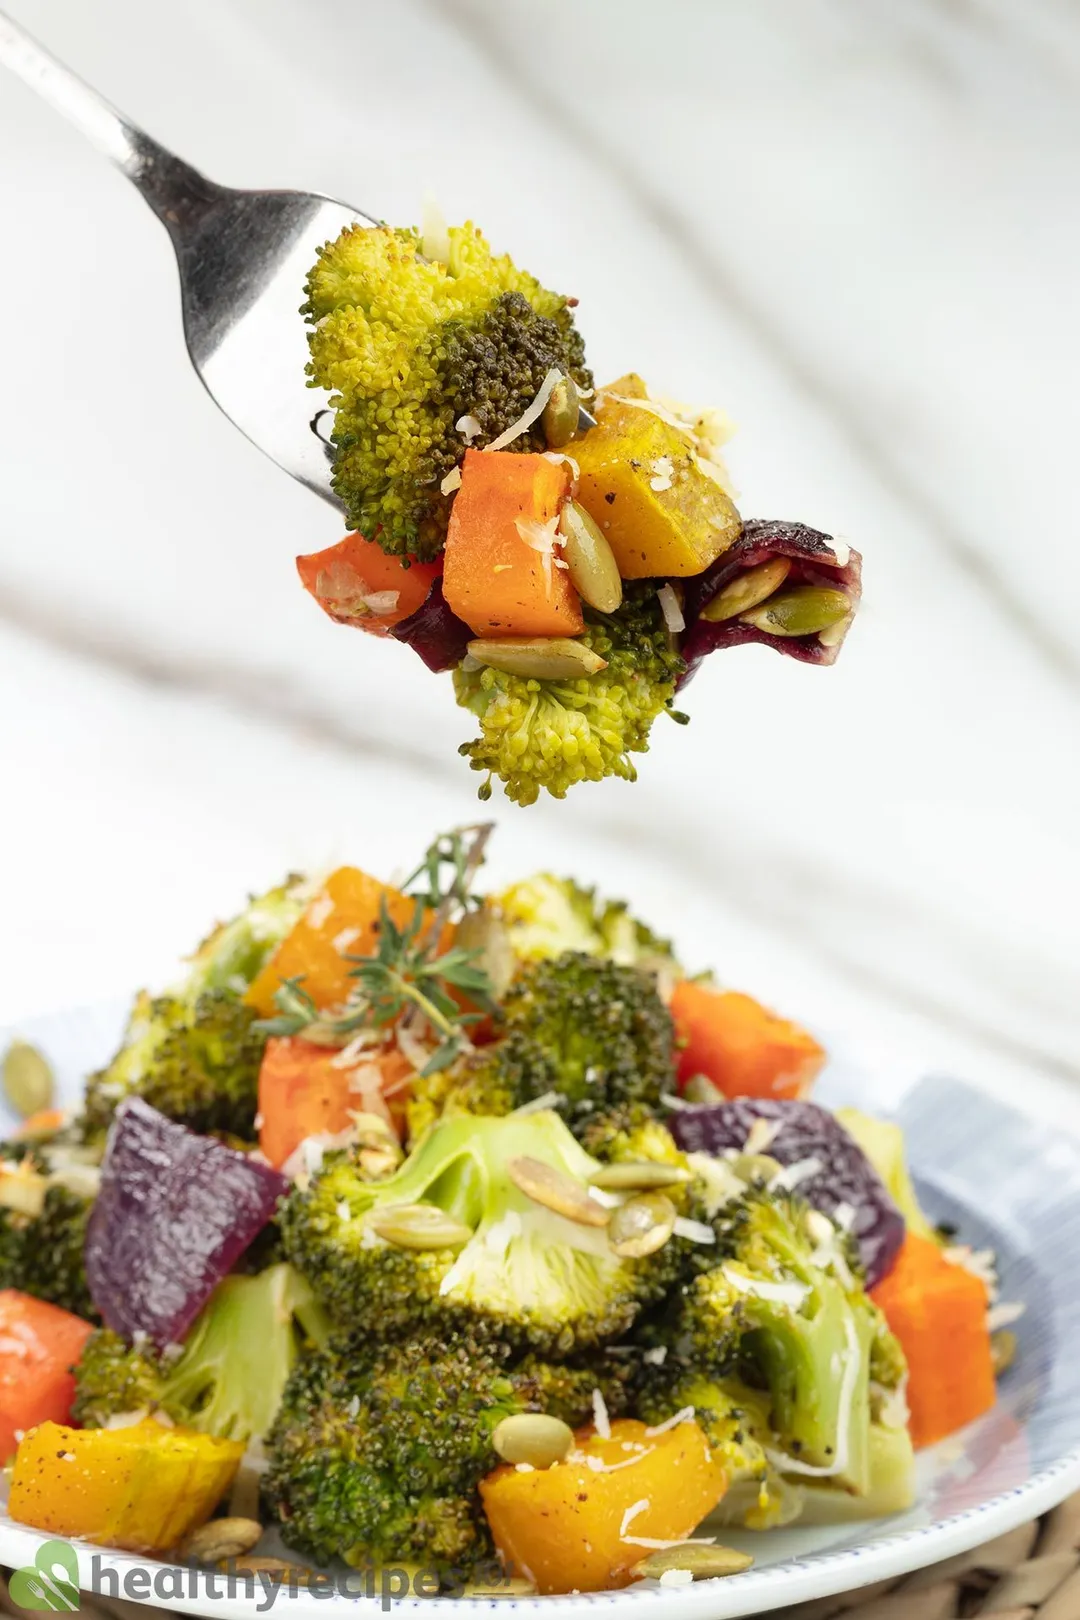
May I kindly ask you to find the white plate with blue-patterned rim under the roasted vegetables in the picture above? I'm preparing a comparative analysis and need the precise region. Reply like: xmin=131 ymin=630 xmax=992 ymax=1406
xmin=0 ymin=1008 xmax=1080 ymax=1620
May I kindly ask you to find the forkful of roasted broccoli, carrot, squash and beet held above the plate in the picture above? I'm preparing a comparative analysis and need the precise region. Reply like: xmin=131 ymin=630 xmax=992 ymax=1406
xmin=296 ymin=222 xmax=861 ymax=804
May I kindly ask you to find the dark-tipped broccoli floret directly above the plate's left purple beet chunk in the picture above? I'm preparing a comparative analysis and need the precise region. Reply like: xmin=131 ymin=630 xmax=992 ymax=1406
xmin=83 ymin=990 xmax=266 ymax=1140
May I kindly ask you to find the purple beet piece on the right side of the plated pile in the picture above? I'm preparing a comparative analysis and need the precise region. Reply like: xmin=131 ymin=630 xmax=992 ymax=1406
xmin=670 ymin=1097 xmax=904 ymax=1288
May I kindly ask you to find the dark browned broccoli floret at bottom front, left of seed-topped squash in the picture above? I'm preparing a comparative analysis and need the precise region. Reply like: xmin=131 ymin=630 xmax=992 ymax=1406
xmin=264 ymin=1335 xmax=622 ymax=1580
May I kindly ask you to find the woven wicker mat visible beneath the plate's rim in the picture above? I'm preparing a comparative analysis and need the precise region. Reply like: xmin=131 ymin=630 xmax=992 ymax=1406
xmin=0 ymin=1495 xmax=1080 ymax=1620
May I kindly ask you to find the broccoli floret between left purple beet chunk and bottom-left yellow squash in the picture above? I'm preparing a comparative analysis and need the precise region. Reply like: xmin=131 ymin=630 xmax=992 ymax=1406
xmin=73 ymin=1265 xmax=327 ymax=1440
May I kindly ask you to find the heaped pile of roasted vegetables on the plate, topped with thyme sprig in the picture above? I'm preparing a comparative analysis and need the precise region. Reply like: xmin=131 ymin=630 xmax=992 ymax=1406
xmin=0 ymin=826 xmax=1007 ymax=1592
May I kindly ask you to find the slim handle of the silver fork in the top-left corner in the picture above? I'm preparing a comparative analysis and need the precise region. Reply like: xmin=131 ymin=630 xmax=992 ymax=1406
xmin=0 ymin=11 xmax=222 ymax=232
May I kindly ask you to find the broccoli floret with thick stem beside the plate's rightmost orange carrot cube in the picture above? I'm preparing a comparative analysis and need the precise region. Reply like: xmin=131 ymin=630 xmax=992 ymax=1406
xmin=674 ymin=1187 xmax=899 ymax=1494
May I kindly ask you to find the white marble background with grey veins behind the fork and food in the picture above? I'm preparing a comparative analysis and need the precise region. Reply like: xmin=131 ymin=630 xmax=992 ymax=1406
xmin=0 ymin=0 xmax=1080 ymax=1116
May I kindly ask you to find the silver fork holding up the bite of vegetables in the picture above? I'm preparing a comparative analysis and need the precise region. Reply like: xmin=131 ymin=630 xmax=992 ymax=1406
xmin=0 ymin=11 xmax=367 ymax=505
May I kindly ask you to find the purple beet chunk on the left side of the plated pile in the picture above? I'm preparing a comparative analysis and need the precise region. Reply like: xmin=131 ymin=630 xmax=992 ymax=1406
xmin=86 ymin=1097 xmax=288 ymax=1349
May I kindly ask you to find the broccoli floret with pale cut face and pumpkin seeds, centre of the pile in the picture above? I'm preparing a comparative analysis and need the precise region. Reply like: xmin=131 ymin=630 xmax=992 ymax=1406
xmin=280 ymin=1111 xmax=672 ymax=1356
